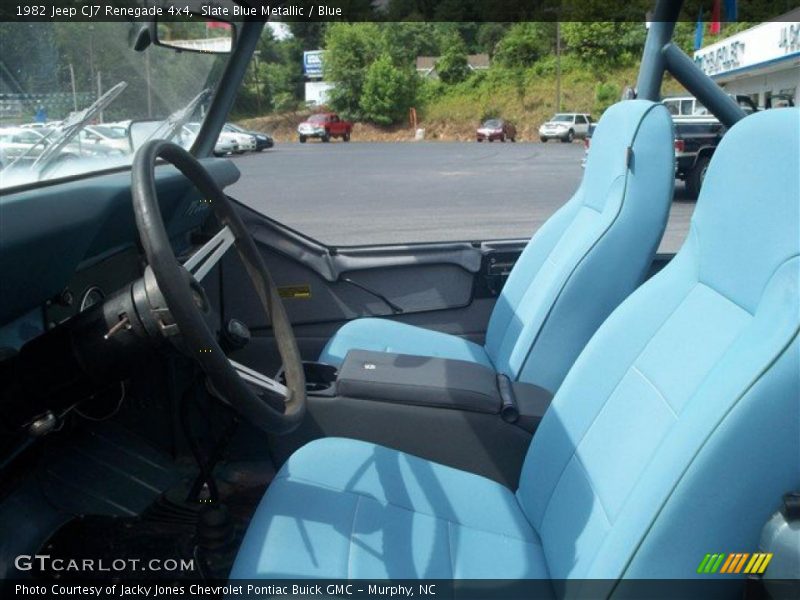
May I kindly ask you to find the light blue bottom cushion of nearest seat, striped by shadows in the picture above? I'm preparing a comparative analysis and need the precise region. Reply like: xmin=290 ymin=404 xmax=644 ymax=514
xmin=231 ymin=438 xmax=548 ymax=579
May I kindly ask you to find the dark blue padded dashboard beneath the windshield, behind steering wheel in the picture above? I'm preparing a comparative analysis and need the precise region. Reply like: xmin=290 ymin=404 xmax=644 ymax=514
xmin=0 ymin=158 xmax=239 ymax=348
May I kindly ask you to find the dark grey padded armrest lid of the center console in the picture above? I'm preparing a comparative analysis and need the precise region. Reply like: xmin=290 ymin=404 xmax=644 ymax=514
xmin=336 ymin=350 xmax=501 ymax=414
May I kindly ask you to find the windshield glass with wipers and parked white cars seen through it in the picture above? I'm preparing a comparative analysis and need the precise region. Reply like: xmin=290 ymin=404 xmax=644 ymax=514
xmin=0 ymin=22 xmax=227 ymax=188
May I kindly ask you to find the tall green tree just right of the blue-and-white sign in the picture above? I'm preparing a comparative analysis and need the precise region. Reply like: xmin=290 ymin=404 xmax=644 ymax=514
xmin=323 ymin=23 xmax=381 ymax=119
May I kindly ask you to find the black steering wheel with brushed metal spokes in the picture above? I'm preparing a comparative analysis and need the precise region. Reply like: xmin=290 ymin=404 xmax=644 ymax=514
xmin=131 ymin=140 xmax=306 ymax=433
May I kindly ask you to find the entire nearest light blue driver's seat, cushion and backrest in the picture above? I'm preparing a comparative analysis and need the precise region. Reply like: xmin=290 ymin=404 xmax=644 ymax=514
xmin=231 ymin=108 xmax=800 ymax=579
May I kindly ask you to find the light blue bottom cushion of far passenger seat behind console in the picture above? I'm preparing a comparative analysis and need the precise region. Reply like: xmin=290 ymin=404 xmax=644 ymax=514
xmin=319 ymin=319 xmax=494 ymax=370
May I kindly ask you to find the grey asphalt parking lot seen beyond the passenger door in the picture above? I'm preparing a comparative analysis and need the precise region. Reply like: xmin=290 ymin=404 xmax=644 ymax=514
xmin=229 ymin=141 xmax=694 ymax=252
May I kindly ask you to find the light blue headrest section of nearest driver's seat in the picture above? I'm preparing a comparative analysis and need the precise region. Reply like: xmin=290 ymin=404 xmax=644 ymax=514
xmin=690 ymin=108 xmax=800 ymax=312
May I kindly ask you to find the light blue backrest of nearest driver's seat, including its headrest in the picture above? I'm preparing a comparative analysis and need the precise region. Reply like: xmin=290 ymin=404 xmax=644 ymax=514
xmin=517 ymin=108 xmax=800 ymax=578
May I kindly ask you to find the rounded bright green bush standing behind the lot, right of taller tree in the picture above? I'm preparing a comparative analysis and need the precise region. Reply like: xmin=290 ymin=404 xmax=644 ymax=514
xmin=360 ymin=54 xmax=416 ymax=125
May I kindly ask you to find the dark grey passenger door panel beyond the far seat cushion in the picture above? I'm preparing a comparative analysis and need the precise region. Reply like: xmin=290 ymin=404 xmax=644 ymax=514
xmin=217 ymin=205 xmax=526 ymax=372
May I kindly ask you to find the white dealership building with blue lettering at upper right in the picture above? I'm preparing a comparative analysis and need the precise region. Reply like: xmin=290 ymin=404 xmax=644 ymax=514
xmin=694 ymin=9 xmax=800 ymax=108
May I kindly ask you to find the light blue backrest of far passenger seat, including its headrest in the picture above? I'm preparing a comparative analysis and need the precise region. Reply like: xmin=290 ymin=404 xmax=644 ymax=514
xmin=486 ymin=100 xmax=675 ymax=391
